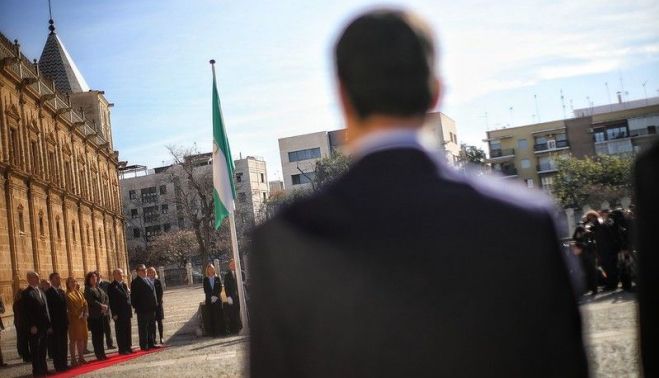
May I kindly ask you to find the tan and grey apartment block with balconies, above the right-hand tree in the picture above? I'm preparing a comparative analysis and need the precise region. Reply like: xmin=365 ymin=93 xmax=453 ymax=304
xmin=484 ymin=99 xmax=659 ymax=192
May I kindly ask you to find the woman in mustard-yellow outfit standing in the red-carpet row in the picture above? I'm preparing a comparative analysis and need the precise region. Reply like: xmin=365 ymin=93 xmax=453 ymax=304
xmin=66 ymin=277 xmax=89 ymax=366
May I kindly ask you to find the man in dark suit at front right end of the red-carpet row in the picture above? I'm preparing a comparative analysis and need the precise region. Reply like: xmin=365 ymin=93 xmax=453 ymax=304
xmin=130 ymin=264 xmax=157 ymax=350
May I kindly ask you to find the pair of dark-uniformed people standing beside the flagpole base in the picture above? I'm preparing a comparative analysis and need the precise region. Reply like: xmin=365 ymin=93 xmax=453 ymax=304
xmin=204 ymin=260 xmax=243 ymax=337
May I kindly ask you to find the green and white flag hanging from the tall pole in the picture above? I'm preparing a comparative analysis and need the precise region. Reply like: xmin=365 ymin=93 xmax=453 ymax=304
xmin=210 ymin=60 xmax=236 ymax=229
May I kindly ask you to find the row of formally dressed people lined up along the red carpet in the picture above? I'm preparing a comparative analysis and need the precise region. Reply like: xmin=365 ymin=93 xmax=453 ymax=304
xmin=0 ymin=265 xmax=164 ymax=376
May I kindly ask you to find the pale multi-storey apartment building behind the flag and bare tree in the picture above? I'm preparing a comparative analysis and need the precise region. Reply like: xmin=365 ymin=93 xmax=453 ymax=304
xmin=120 ymin=153 xmax=270 ymax=251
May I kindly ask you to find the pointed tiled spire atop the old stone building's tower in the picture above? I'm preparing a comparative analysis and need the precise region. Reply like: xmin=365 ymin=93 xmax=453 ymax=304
xmin=39 ymin=4 xmax=89 ymax=93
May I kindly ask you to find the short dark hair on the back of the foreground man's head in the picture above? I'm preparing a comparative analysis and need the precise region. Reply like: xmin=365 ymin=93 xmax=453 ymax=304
xmin=334 ymin=9 xmax=435 ymax=118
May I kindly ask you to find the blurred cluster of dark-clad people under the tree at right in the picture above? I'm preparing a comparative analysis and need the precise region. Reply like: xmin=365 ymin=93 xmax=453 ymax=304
xmin=572 ymin=210 xmax=635 ymax=295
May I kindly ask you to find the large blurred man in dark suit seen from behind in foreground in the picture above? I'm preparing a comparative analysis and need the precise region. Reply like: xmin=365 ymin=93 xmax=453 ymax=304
xmin=250 ymin=10 xmax=588 ymax=377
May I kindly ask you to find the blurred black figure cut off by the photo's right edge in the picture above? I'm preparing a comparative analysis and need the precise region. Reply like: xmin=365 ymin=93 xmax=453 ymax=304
xmin=634 ymin=142 xmax=659 ymax=377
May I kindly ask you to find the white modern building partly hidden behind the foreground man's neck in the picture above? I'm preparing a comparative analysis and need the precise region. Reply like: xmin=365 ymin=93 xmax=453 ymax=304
xmin=279 ymin=112 xmax=460 ymax=190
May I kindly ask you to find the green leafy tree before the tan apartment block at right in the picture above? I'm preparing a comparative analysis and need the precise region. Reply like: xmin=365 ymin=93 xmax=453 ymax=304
xmin=553 ymin=155 xmax=633 ymax=208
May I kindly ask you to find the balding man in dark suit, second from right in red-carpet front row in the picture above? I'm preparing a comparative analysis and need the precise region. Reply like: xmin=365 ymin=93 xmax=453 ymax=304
xmin=108 ymin=269 xmax=133 ymax=354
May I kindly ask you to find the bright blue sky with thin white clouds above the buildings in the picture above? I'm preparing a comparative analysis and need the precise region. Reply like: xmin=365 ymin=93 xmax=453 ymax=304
xmin=0 ymin=0 xmax=659 ymax=180
